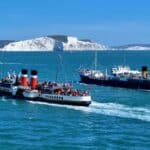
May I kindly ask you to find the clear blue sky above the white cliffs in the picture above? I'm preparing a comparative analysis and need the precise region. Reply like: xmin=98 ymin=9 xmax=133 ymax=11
xmin=0 ymin=0 xmax=150 ymax=45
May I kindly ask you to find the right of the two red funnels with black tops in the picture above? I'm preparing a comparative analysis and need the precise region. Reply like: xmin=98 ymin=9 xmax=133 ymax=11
xmin=30 ymin=70 xmax=37 ymax=90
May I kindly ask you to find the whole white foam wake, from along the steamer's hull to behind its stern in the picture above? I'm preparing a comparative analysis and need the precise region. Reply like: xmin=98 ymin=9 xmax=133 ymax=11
xmin=27 ymin=101 xmax=150 ymax=122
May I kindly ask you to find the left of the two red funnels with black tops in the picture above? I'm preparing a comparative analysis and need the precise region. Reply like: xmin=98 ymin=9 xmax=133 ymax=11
xmin=21 ymin=69 xmax=28 ymax=86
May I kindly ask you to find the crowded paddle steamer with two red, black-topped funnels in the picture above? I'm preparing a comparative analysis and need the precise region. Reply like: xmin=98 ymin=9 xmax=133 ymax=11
xmin=0 ymin=69 xmax=92 ymax=106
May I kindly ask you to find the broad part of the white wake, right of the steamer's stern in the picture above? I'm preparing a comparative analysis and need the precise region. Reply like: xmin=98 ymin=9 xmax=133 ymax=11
xmin=91 ymin=102 xmax=150 ymax=122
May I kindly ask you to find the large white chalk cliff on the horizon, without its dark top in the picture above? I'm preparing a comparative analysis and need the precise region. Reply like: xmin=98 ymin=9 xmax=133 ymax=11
xmin=1 ymin=36 xmax=109 ymax=51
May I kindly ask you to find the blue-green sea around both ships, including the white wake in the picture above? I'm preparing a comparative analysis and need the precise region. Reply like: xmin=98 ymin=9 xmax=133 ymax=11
xmin=0 ymin=51 xmax=150 ymax=150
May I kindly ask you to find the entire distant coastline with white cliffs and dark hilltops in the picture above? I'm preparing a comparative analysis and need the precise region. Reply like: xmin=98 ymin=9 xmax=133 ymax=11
xmin=0 ymin=35 xmax=150 ymax=52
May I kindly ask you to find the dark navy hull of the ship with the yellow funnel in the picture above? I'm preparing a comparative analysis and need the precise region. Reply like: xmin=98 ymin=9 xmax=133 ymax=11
xmin=80 ymin=75 xmax=150 ymax=90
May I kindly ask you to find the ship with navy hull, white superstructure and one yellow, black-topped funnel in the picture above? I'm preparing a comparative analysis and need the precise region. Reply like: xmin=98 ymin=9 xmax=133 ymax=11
xmin=79 ymin=66 xmax=150 ymax=90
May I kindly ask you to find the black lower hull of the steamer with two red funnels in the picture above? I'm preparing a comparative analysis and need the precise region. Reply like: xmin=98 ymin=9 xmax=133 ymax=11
xmin=0 ymin=91 xmax=91 ymax=106
